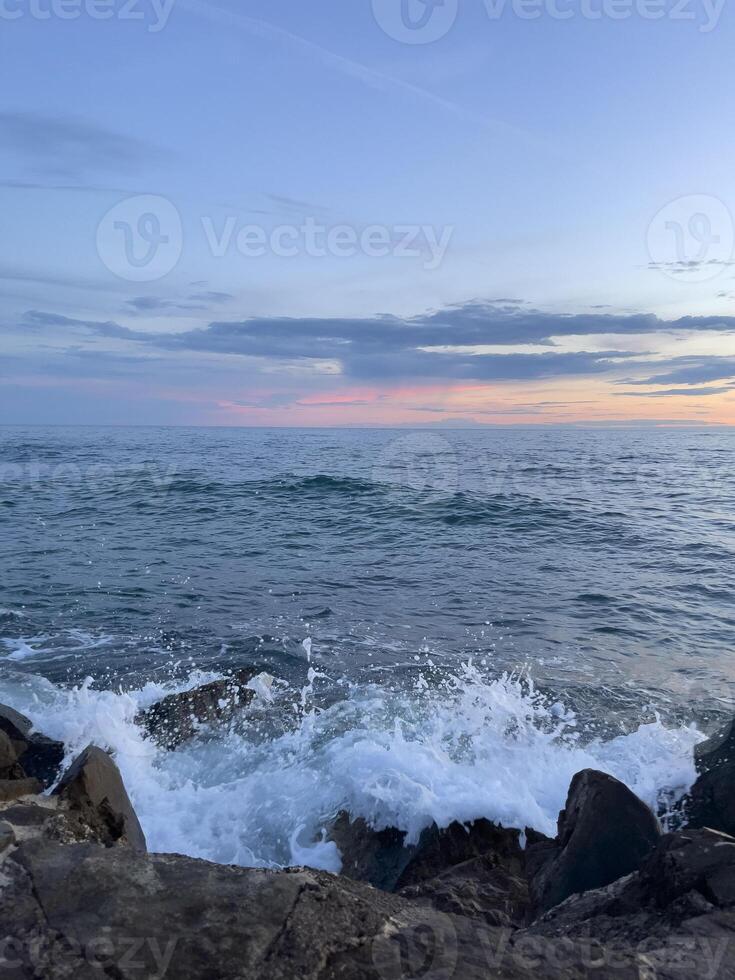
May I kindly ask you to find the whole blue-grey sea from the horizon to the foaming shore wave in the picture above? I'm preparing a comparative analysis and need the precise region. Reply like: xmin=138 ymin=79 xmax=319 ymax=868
xmin=0 ymin=426 xmax=735 ymax=871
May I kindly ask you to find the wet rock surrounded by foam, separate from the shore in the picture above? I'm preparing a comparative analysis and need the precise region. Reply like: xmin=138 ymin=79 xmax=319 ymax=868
xmin=135 ymin=670 xmax=273 ymax=749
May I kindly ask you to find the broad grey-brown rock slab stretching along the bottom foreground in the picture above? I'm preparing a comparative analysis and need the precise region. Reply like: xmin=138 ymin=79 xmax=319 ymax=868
xmin=0 ymin=841 xmax=656 ymax=980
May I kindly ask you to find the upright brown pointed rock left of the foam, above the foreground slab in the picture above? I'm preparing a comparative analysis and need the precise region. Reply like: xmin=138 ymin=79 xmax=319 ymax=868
xmin=54 ymin=745 xmax=146 ymax=851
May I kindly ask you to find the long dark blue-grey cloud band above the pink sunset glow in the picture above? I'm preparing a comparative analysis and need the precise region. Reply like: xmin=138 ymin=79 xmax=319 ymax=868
xmin=12 ymin=300 xmax=735 ymax=387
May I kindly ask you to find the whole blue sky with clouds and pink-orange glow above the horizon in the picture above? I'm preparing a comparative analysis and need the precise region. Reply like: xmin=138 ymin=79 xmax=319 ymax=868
xmin=0 ymin=0 xmax=735 ymax=426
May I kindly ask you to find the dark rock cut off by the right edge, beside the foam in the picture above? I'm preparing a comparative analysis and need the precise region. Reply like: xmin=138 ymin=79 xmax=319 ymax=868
xmin=683 ymin=720 xmax=735 ymax=835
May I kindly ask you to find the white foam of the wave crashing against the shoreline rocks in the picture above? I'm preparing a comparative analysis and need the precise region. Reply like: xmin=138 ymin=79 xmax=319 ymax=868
xmin=2 ymin=666 xmax=702 ymax=871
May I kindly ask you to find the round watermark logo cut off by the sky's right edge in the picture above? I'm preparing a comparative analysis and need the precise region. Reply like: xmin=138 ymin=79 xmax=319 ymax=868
xmin=646 ymin=194 xmax=735 ymax=283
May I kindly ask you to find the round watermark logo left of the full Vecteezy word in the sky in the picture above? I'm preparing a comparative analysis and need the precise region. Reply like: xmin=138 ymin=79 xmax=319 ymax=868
xmin=97 ymin=194 xmax=183 ymax=282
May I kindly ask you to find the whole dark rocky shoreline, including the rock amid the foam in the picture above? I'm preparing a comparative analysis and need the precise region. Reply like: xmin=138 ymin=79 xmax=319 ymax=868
xmin=0 ymin=676 xmax=735 ymax=980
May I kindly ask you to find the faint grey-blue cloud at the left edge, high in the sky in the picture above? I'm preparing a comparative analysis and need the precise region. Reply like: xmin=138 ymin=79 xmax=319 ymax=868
xmin=0 ymin=112 xmax=160 ymax=178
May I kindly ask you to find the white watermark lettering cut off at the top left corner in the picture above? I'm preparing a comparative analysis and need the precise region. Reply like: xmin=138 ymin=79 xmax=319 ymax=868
xmin=0 ymin=0 xmax=176 ymax=34
